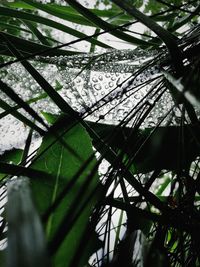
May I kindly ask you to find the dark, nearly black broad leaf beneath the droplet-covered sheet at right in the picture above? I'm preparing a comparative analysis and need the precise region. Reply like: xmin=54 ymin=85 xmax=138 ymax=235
xmin=91 ymin=123 xmax=200 ymax=173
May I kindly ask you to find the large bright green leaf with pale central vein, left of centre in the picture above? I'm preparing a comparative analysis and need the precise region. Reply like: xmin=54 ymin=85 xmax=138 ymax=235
xmin=31 ymin=117 xmax=99 ymax=267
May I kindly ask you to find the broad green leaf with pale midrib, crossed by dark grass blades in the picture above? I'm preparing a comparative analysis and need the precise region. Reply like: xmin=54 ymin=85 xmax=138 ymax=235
xmin=31 ymin=117 xmax=101 ymax=267
